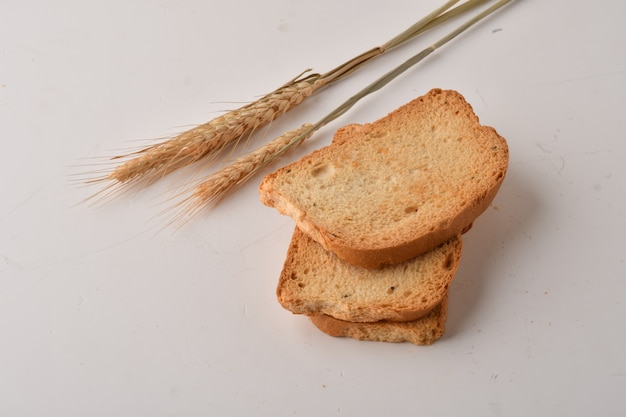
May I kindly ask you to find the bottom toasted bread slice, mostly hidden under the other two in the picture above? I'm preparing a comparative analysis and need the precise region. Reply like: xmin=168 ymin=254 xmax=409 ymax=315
xmin=311 ymin=294 xmax=448 ymax=345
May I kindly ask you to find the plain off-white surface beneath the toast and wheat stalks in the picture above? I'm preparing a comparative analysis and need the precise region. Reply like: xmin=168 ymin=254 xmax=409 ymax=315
xmin=0 ymin=0 xmax=626 ymax=417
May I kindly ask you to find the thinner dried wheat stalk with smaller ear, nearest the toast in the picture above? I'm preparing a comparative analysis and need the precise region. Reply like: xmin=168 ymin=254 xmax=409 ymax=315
xmin=183 ymin=0 xmax=512 ymax=217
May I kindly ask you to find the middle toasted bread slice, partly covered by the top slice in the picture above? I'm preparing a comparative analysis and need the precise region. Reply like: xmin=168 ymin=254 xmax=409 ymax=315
xmin=276 ymin=227 xmax=462 ymax=322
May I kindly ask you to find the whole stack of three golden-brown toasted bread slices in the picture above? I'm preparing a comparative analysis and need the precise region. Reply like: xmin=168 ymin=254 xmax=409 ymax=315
xmin=260 ymin=89 xmax=508 ymax=345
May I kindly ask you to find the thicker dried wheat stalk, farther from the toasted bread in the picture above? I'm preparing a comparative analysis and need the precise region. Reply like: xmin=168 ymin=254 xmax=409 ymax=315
xmin=87 ymin=0 xmax=488 ymax=197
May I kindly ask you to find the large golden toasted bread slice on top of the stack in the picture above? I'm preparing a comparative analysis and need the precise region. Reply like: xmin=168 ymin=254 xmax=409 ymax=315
xmin=259 ymin=89 xmax=509 ymax=268
